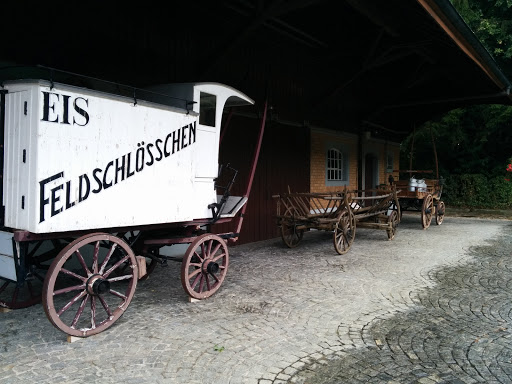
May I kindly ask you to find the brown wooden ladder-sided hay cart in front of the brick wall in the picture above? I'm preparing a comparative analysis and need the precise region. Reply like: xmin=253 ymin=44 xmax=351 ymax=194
xmin=272 ymin=189 xmax=400 ymax=255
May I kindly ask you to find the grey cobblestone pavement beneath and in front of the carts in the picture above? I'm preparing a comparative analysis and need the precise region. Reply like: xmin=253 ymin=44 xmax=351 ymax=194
xmin=0 ymin=213 xmax=512 ymax=384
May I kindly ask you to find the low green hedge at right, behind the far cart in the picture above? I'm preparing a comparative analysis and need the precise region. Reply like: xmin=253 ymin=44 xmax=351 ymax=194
xmin=442 ymin=174 xmax=512 ymax=209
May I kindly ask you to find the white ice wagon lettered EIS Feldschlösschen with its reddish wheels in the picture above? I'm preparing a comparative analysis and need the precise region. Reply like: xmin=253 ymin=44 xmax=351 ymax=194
xmin=0 ymin=70 xmax=266 ymax=337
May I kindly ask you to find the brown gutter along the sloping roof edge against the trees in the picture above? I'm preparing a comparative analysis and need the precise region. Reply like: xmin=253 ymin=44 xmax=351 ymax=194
xmin=417 ymin=0 xmax=512 ymax=101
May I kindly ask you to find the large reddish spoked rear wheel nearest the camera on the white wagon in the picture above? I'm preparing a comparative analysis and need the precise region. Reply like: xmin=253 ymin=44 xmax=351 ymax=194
xmin=43 ymin=233 xmax=138 ymax=337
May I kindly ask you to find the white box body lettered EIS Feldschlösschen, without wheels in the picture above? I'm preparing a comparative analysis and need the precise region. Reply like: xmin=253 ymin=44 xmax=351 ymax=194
xmin=3 ymin=81 xmax=252 ymax=233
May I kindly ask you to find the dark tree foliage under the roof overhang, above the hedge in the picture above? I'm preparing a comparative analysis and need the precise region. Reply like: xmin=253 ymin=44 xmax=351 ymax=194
xmin=401 ymin=105 xmax=512 ymax=177
